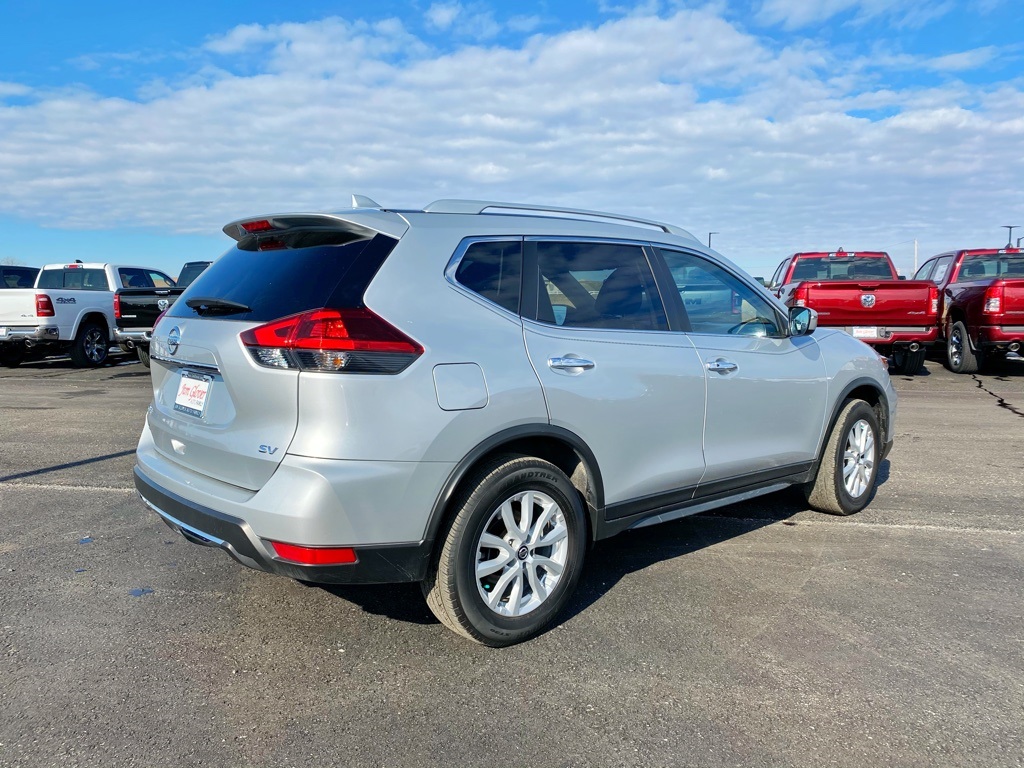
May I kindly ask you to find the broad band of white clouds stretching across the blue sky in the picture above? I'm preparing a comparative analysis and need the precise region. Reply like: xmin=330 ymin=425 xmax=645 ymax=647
xmin=0 ymin=9 xmax=1024 ymax=273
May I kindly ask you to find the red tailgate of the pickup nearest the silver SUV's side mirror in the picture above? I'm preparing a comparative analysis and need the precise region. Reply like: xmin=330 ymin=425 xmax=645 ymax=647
xmin=805 ymin=280 xmax=938 ymax=327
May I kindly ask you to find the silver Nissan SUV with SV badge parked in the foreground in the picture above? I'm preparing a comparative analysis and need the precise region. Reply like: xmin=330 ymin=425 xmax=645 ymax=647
xmin=135 ymin=199 xmax=896 ymax=646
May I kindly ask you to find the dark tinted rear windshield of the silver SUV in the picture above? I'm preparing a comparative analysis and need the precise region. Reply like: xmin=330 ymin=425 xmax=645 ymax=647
xmin=167 ymin=234 xmax=397 ymax=323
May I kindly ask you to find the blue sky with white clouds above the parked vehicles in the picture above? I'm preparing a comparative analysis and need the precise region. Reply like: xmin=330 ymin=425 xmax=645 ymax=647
xmin=0 ymin=0 xmax=1024 ymax=274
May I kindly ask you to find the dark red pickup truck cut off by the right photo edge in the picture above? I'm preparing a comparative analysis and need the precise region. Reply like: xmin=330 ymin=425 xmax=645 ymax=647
xmin=914 ymin=248 xmax=1024 ymax=374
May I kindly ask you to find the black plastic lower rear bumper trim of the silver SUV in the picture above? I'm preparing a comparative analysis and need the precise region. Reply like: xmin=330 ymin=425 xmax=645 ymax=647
xmin=135 ymin=467 xmax=431 ymax=584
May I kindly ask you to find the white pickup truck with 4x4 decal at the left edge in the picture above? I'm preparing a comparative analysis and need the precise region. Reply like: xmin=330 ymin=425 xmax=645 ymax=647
xmin=0 ymin=262 xmax=174 ymax=368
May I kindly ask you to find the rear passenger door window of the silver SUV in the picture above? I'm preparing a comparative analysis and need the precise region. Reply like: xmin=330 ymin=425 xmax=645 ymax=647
xmin=527 ymin=242 xmax=669 ymax=331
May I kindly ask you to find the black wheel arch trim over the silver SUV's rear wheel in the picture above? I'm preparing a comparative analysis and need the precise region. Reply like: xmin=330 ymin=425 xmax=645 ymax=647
xmin=423 ymin=424 xmax=604 ymax=543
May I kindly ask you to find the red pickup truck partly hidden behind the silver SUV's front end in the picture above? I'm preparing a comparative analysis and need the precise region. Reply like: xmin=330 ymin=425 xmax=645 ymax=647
xmin=768 ymin=248 xmax=939 ymax=374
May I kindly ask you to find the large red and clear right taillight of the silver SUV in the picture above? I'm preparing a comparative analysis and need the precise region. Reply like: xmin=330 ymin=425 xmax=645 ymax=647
xmin=240 ymin=309 xmax=423 ymax=374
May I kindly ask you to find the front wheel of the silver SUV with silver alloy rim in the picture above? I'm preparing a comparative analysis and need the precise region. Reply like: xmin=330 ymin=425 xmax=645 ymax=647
xmin=805 ymin=400 xmax=882 ymax=515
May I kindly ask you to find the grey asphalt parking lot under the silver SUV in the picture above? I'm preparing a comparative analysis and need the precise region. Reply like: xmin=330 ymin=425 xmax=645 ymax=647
xmin=0 ymin=356 xmax=1024 ymax=767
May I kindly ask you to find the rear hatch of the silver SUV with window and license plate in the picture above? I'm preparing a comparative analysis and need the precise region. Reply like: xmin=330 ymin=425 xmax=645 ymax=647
xmin=148 ymin=215 xmax=405 ymax=490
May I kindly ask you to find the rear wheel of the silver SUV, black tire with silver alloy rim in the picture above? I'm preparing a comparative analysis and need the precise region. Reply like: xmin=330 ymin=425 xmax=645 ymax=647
xmin=421 ymin=454 xmax=587 ymax=647
